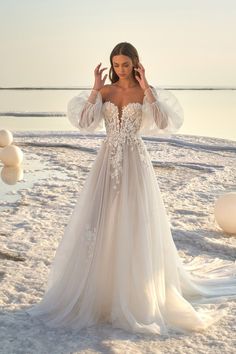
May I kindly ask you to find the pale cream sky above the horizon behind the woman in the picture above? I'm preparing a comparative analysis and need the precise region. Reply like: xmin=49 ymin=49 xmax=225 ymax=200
xmin=0 ymin=0 xmax=236 ymax=86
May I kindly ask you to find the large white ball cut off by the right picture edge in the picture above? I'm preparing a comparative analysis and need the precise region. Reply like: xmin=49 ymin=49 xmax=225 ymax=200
xmin=214 ymin=192 xmax=236 ymax=234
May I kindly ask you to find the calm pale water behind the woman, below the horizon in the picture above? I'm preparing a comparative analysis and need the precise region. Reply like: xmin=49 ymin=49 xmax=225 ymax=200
xmin=0 ymin=88 xmax=236 ymax=140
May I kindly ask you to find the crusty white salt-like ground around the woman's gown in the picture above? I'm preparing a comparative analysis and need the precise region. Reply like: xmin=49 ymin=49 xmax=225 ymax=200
xmin=0 ymin=132 xmax=236 ymax=354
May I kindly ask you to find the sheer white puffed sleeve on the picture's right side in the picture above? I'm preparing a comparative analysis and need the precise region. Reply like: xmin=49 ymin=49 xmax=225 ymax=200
xmin=140 ymin=87 xmax=184 ymax=135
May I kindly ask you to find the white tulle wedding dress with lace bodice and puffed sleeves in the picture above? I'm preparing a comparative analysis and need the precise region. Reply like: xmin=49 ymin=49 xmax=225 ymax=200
xmin=26 ymin=87 xmax=236 ymax=334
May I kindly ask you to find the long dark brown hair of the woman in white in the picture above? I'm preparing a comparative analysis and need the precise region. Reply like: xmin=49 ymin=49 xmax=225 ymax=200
xmin=109 ymin=42 xmax=139 ymax=83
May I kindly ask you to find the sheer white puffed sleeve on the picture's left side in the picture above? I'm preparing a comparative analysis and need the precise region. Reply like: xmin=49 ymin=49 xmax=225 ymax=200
xmin=67 ymin=90 xmax=105 ymax=134
